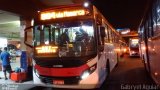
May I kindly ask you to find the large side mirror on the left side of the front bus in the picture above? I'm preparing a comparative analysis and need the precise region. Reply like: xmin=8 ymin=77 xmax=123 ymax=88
xmin=24 ymin=26 xmax=33 ymax=48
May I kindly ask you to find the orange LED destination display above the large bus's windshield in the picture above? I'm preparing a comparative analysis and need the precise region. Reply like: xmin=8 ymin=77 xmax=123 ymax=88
xmin=40 ymin=9 xmax=86 ymax=20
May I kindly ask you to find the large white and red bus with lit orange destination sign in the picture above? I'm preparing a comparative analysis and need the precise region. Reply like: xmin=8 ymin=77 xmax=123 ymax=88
xmin=24 ymin=3 xmax=120 ymax=89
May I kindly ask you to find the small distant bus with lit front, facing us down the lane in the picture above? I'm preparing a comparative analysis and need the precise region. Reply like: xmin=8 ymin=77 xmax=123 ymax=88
xmin=129 ymin=37 xmax=139 ymax=56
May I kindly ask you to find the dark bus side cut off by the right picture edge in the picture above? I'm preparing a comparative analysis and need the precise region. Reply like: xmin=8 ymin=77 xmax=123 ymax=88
xmin=138 ymin=0 xmax=160 ymax=85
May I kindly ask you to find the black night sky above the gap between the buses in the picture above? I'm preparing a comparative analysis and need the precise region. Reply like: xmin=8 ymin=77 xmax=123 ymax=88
xmin=93 ymin=0 xmax=147 ymax=30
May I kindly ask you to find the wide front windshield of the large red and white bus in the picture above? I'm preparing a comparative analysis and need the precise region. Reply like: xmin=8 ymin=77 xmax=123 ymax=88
xmin=34 ymin=20 xmax=96 ymax=57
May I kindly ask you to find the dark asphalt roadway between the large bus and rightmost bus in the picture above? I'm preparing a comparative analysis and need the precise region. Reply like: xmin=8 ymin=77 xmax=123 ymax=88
xmin=100 ymin=55 xmax=159 ymax=90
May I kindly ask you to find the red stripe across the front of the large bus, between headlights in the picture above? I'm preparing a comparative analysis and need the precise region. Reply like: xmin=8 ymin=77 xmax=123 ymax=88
xmin=35 ymin=64 xmax=89 ymax=77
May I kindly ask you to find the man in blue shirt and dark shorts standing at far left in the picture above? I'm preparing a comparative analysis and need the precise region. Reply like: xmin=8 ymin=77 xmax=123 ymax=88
xmin=0 ymin=47 xmax=12 ymax=80
